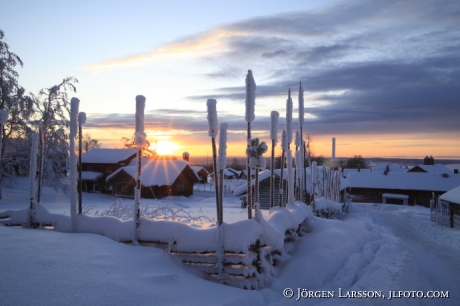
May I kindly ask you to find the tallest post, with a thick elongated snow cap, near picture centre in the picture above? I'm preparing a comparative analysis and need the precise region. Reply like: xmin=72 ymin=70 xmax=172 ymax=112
xmin=245 ymin=70 xmax=256 ymax=219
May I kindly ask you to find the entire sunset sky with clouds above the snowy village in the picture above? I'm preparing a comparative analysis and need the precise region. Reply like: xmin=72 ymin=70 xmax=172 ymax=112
xmin=0 ymin=0 xmax=460 ymax=160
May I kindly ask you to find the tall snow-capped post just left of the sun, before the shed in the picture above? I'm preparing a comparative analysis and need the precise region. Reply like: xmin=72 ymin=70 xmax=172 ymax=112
xmin=133 ymin=95 xmax=147 ymax=245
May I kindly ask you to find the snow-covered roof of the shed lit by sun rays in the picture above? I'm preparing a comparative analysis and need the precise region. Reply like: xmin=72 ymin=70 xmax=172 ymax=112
xmin=106 ymin=159 xmax=196 ymax=186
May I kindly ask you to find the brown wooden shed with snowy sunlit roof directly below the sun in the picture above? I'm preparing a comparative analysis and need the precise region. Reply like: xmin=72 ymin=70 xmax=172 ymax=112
xmin=106 ymin=160 xmax=198 ymax=199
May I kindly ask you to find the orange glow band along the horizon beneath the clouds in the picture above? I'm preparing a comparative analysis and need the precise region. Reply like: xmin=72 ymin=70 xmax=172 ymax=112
xmin=84 ymin=129 xmax=460 ymax=159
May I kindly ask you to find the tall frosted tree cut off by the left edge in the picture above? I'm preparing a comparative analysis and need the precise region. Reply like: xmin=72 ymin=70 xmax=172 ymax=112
xmin=0 ymin=30 xmax=34 ymax=199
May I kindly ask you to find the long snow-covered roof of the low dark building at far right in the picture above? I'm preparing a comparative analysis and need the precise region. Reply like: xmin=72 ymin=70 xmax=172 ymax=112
xmin=341 ymin=172 xmax=460 ymax=191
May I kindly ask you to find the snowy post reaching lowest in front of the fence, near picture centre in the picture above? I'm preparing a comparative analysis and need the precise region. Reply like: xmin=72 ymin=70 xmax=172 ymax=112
xmin=216 ymin=123 xmax=228 ymax=284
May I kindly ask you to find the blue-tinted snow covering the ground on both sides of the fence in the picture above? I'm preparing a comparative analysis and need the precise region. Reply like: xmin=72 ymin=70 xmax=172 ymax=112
xmin=0 ymin=178 xmax=460 ymax=305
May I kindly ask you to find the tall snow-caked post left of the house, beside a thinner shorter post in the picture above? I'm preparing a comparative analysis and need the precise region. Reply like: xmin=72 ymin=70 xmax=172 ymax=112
xmin=69 ymin=98 xmax=80 ymax=233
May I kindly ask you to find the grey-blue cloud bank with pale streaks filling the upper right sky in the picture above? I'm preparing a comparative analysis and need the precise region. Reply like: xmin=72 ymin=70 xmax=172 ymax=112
xmin=83 ymin=0 xmax=460 ymax=139
